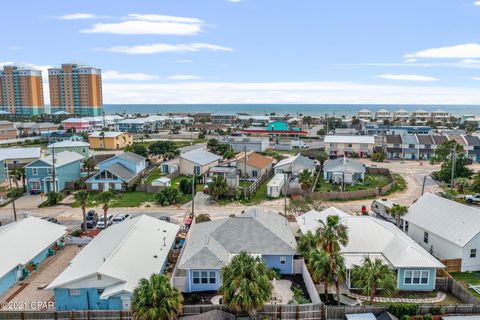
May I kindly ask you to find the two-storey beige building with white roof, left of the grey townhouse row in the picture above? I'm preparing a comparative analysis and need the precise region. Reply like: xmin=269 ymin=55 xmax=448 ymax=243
xmin=325 ymin=135 xmax=375 ymax=158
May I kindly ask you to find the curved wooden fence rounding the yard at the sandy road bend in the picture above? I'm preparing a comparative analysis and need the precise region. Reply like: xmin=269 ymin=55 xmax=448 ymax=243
xmin=311 ymin=168 xmax=395 ymax=200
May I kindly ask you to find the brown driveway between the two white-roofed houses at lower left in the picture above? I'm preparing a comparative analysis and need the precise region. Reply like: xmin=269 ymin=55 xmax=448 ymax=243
xmin=0 ymin=245 xmax=82 ymax=311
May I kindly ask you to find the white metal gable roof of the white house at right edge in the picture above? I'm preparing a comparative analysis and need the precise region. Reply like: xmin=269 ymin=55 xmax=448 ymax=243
xmin=403 ymin=193 xmax=480 ymax=247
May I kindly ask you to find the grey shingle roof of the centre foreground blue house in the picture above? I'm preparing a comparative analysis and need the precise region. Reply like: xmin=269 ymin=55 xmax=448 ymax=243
xmin=178 ymin=208 xmax=297 ymax=269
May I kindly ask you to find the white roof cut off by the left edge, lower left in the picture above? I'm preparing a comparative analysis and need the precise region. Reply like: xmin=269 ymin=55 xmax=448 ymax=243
xmin=0 ymin=216 xmax=67 ymax=278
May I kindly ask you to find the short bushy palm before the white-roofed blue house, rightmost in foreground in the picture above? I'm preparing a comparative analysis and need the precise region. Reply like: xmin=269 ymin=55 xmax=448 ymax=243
xmin=352 ymin=257 xmax=397 ymax=304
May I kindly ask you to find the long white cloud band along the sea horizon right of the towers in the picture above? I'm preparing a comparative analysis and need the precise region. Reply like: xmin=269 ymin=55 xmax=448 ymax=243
xmin=103 ymin=81 xmax=480 ymax=104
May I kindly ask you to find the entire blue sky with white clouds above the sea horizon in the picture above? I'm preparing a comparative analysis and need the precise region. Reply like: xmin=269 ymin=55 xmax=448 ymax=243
xmin=0 ymin=0 xmax=480 ymax=104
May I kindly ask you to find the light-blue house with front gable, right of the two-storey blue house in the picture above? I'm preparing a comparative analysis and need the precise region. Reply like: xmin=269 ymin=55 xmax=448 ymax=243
xmin=85 ymin=152 xmax=147 ymax=191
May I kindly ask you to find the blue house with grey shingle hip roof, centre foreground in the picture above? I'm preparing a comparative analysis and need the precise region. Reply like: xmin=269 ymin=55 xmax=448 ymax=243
xmin=173 ymin=208 xmax=297 ymax=292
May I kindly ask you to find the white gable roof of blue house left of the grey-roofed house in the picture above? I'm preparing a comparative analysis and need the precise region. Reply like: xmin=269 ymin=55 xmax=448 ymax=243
xmin=48 ymin=215 xmax=179 ymax=299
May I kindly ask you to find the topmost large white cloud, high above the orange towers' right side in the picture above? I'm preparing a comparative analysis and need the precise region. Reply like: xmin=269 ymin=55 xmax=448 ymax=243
xmin=80 ymin=13 xmax=203 ymax=35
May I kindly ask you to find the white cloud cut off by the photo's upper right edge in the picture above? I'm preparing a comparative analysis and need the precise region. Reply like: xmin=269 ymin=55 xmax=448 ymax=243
xmin=406 ymin=43 xmax=480 ymax=59
